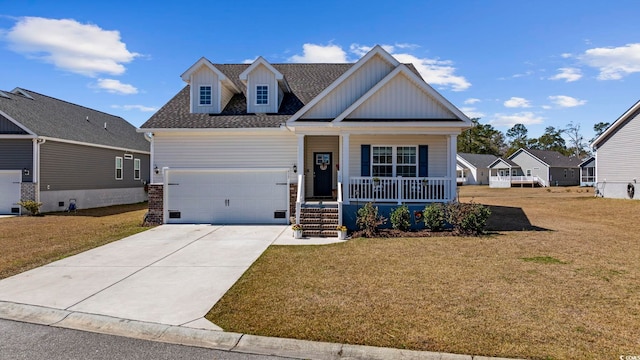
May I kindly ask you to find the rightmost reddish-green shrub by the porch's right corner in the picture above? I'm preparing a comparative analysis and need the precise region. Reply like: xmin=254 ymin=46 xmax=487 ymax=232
xmin=447 ymin=203 xmax=491 ymax=235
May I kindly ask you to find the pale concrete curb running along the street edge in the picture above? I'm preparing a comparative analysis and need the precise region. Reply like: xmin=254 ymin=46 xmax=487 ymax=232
xmin=0 ymin=301 xmax=524 ymax=360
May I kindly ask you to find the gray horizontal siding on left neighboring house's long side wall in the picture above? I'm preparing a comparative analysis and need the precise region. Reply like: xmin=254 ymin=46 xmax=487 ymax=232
xmin=40 ymin=140 xmax=149 ymax=191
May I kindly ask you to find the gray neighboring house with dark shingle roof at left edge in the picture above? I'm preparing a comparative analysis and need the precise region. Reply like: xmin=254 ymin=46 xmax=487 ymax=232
xmin=0 ymin=88 xmax=150 ymax=214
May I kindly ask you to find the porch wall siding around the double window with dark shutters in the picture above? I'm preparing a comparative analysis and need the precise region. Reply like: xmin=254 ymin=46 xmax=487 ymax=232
xmin=349 ymin=135 xmax=448 ymax=177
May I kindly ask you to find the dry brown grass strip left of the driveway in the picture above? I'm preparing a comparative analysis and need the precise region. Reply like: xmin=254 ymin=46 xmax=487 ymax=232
xmin=0 ymin=203 xmax=147 ymax=279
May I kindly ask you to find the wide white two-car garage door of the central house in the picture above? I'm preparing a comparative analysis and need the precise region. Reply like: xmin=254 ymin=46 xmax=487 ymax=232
xmin=165 ymin=169 xmax=289 ymax=224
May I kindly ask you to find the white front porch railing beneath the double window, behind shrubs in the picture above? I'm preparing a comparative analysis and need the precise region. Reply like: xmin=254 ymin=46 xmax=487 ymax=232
xmin=349 ymin=176 xmax=456 ymax=204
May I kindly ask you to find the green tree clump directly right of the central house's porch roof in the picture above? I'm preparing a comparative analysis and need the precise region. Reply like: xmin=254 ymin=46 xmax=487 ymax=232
xmin=458 ymin=118 xmax=505 ymax=156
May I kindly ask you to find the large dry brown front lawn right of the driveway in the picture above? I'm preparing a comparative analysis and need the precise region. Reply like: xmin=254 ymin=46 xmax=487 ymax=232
xmin=207 ymin=187 xmax=640 ymax=359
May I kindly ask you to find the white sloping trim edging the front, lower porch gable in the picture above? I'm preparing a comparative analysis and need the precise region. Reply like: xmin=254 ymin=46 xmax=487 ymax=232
xmin=332 ymin=64 xmax=471 ymax=123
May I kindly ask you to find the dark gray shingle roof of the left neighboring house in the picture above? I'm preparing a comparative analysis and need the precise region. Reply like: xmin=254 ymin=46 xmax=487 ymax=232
xmin=0 ymin=89 xmax=150 ymax=151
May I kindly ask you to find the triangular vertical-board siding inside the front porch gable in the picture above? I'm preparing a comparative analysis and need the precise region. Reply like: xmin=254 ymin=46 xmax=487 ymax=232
xmin=347 ymin=74 xmax=456 ymax=120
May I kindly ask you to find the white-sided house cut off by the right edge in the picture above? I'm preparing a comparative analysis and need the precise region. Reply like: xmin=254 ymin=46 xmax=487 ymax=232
xmin=591 ymin=101 xmax=640 ymax=199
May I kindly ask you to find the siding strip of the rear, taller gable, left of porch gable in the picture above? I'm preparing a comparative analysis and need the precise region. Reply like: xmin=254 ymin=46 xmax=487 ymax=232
xmin=302 ymin=55 xmax=393 ymax=119
